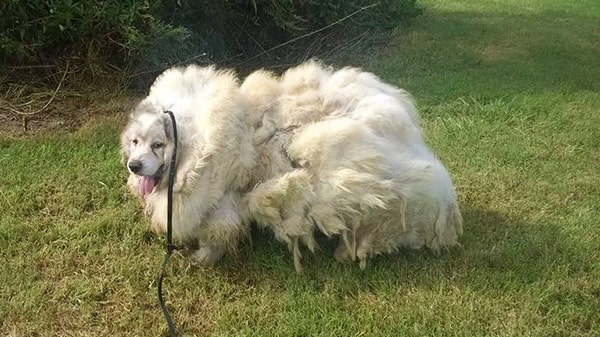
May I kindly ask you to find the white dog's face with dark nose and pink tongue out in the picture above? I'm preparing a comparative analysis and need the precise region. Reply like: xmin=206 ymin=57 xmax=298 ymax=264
xmin=121 ymin=104 xmax=173 ymax=197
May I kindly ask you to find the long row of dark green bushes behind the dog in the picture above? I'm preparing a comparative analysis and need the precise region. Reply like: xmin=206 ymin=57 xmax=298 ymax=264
xmin=0 ymin=0 xmax=419 ymax=83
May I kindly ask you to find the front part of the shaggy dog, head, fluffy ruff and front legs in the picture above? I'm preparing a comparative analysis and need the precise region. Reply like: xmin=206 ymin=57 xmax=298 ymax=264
xmin=121 ymin=66 xmax=254 ymax=264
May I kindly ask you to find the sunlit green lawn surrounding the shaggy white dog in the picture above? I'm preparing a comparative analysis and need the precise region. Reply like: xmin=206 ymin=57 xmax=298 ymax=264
xmin=0 ymin=0 xmax=600 ymax=337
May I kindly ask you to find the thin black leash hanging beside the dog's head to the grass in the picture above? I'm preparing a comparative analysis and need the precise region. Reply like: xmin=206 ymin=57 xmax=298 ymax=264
xmin=156 ymin=110 xmax=177 ymax=337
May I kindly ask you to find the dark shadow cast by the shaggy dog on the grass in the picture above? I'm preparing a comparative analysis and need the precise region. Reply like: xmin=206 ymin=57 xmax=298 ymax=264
xmin=193 ymin=203 xmax=592 ymax=297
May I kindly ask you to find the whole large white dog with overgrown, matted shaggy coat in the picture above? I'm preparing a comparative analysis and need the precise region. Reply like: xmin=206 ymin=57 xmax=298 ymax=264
xmin=121 ymin=61 xmax=463 ymax=272
